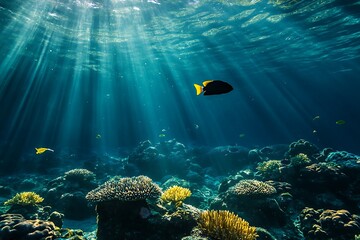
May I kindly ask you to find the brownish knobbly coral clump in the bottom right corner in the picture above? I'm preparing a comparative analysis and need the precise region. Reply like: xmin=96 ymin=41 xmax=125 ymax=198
xmin=300 ymin=208 xmax=360 ymax=240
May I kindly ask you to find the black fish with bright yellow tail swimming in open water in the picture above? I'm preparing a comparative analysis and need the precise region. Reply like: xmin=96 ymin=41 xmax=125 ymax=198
xmin=194 ymin=80 xmax=233 ymax=95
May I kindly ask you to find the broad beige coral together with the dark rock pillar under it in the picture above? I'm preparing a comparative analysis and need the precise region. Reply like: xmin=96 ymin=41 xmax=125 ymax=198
xmin=86 ymin=175 xmax=162 ymax=240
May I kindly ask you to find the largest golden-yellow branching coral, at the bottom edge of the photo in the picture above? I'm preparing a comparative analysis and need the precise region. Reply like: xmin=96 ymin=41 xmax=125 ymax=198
xmin=198 ymin=210 xmax=258 ymax=240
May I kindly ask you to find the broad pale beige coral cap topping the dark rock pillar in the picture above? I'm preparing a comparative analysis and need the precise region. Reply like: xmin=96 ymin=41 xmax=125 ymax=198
xmin=86 ymin=175 xmax=162 ymax=202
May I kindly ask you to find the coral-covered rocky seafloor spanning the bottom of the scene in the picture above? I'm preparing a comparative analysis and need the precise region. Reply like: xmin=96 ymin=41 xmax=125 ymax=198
xmin=0 ymin=139 xmax=360 ymax=240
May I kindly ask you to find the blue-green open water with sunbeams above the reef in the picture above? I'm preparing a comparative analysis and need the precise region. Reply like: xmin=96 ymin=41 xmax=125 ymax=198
xmin=0 ymin=0 xmax=360 ymax=239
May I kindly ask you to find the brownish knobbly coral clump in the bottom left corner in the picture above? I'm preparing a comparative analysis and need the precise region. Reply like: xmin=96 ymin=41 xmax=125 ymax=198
xmin=0 ymin=214 xmax=60 ymax=240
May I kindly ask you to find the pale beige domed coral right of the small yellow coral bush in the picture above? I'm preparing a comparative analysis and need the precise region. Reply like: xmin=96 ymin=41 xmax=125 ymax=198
xmin=230 ymin=179 xmax=276 ymax=197
